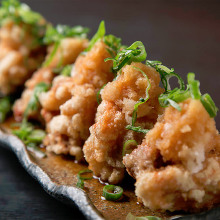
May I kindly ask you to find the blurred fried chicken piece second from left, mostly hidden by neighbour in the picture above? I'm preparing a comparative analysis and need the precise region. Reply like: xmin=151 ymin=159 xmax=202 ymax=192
xmin=13 ymin=38 xmax=88 ymax=121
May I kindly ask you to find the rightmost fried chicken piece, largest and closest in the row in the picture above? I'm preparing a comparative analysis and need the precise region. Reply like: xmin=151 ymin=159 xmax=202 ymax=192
xmin=123 ymin=98 xmax=220 ymax=212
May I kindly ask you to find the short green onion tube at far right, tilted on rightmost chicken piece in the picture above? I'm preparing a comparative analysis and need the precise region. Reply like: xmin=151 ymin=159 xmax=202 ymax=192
xmin=201 ymin=93 xmax=218 ymax=118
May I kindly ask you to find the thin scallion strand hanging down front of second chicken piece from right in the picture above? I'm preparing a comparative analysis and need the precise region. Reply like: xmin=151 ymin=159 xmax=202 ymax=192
xmin=126 ymin=66 xmax=151 ymax=134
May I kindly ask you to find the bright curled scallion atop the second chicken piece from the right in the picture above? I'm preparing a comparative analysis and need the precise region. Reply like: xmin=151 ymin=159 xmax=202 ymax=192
xmin=105 ymin=41 xmax=147 ymax=73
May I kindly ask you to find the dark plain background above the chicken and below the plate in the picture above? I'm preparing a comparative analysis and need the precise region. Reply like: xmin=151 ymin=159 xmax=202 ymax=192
xmin=0 ymin=0 xmax=220 ymax=220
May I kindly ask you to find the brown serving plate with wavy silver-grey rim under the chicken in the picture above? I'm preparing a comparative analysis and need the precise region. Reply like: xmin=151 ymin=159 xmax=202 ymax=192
xmin=0 ymin=126 xmax=220 ymax=220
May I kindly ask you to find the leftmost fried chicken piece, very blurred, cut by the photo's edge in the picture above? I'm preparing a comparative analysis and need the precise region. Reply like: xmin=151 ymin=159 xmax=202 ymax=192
xmin=0 ymin=21 xmax=46 ymax=95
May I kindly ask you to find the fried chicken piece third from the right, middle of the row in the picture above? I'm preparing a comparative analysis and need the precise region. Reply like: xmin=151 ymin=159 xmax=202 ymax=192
xmin=40 ymin=41 xmax=113 ymax=161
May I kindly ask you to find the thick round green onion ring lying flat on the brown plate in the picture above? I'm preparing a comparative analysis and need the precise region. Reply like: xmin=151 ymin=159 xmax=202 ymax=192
xmin=103 ymin=185 xmax=123 ymax=201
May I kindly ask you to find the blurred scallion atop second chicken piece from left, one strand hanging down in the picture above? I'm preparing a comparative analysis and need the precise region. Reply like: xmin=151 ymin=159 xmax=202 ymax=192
xmin=43 ymin=24 xmax=89 ymax=67
